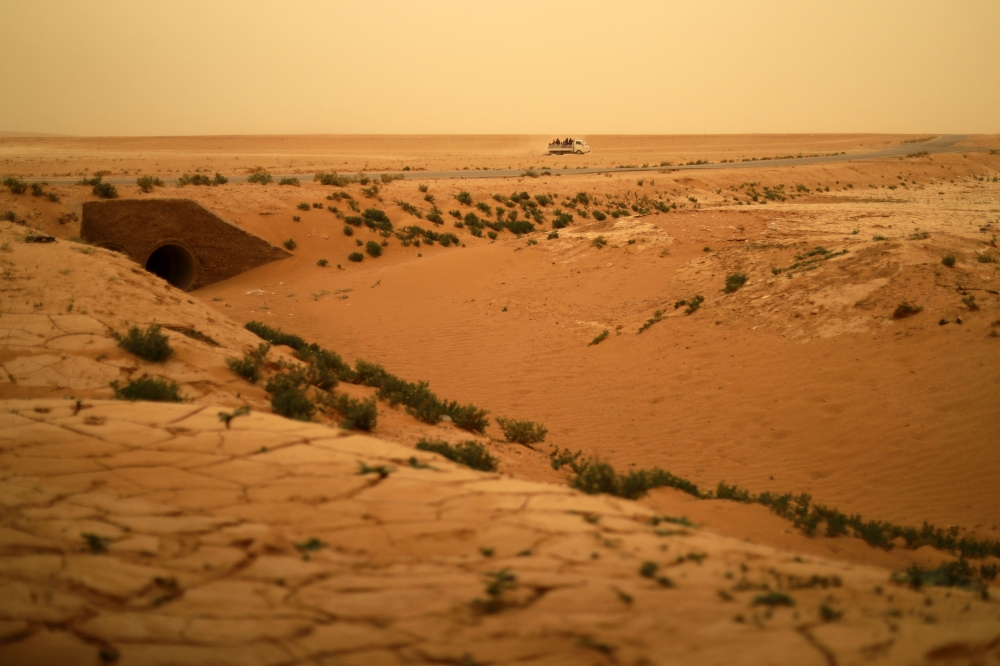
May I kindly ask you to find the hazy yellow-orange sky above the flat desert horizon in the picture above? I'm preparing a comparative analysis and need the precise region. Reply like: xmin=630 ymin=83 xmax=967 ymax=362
xmin=0 ymin=0 xmax=1000 ymax=135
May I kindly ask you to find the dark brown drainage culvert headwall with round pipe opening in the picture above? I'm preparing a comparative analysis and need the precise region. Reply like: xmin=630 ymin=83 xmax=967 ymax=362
xmin=80 ymin=199 xmax=292 ymax=291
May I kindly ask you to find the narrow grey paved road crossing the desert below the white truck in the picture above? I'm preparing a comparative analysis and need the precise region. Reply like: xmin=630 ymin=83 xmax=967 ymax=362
xmin=36 ymin=134 xmax=986 ymax=185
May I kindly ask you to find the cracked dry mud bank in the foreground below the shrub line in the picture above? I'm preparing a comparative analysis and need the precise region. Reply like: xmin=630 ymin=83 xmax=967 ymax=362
xmin=0 ymin=400 xmax=998 ymax=665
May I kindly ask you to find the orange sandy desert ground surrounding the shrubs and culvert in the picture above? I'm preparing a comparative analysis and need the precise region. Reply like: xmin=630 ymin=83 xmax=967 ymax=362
xmin=0 ymin=135 xmax=1000 ymax=664
